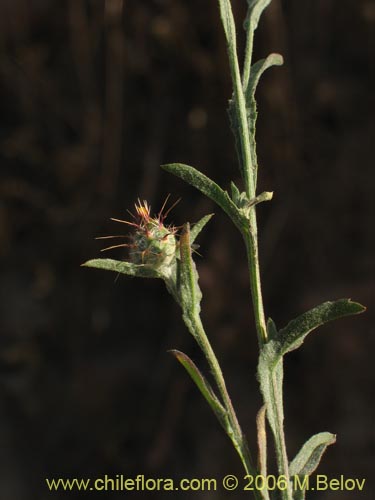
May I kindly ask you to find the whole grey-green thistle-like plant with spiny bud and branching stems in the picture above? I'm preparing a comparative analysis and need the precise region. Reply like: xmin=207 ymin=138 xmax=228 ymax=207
xmin=84 ymin=0 xmax=365 ymax=500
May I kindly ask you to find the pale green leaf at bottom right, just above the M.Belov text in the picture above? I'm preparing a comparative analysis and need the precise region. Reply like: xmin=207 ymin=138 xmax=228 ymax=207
xmin=289 ymin=432 xmax=336 ymax=477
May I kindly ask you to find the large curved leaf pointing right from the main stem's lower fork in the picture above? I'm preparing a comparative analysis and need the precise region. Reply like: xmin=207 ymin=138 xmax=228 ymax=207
xmin=274 ymin=299 xmax=366 ymax=363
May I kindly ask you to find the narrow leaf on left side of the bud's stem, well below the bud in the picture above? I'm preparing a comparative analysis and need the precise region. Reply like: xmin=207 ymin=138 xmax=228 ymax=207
xmin=170 ymin=349 xmax=228 ymax=430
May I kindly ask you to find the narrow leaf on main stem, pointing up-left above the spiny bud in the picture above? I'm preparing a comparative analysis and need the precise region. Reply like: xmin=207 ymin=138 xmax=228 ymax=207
xmin=162 ymin=163 xmax=248 ymax=230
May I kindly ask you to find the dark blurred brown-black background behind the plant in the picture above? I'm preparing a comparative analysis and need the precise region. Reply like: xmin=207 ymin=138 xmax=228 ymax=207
xmin=0 ymin=0 xmax=375 ymax=500
